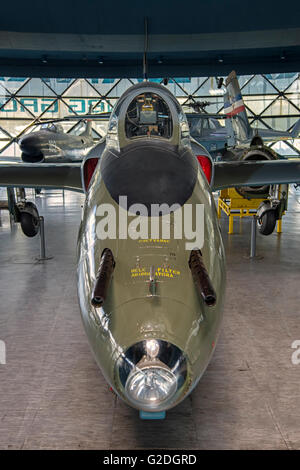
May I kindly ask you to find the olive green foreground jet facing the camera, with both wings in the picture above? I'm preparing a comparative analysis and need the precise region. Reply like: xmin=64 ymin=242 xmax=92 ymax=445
xmin=0 ymin=82 xmax=300 ymax=419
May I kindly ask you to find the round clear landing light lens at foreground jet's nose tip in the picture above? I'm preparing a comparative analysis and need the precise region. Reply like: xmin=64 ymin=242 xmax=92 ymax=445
xmin=125 ymin=366 xmax=177 ymax=409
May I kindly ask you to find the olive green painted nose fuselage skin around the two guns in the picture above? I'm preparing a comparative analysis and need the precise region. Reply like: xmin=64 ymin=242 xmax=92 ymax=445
xmin=78 ymin=156 xmax=225 ymax=409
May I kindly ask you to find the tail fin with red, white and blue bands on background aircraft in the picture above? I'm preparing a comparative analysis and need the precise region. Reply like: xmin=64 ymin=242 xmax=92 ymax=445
xmin=224 ymin=70 xmax=252 ymax=141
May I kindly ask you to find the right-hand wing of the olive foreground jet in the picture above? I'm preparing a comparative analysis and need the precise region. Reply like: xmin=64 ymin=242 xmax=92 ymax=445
xmin=212 ymin=160 xmax=300 ymax=190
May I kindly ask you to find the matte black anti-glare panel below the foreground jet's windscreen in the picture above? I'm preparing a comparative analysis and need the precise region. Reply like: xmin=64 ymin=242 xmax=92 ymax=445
xmin=101 ymin=141 xmax=197 ymax=210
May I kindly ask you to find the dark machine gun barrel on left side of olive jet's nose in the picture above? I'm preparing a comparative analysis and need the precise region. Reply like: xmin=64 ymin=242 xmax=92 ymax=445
xmin=91 ymin=248 xmax=116 ymax=308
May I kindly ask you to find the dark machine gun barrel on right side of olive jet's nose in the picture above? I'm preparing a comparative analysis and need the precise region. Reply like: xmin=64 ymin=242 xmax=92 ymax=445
xmin=189 ymin=250 xmax=217 ymax=307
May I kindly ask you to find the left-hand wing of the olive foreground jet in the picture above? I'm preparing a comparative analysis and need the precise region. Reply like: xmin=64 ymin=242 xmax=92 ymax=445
xmin=0 ymin=163 xmax=83 ymax=191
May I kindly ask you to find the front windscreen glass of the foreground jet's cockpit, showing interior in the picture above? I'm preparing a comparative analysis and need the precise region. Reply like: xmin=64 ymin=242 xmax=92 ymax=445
xmin=125 ymin=93 xmax=173 ymax=139
